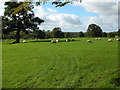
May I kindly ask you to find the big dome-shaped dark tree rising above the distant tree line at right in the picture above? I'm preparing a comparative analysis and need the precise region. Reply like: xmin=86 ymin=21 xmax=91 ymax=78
xmin=86 ymin=24 xmax=102 ymax=37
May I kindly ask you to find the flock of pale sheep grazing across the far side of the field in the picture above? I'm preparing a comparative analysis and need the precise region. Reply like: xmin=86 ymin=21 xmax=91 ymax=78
xmin=23 ymin=38 xmax=120 ymax=43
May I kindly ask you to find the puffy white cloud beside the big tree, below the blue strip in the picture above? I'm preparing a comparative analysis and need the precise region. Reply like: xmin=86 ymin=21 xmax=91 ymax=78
xmin=35 ymin=6 xmax=81 ymax=31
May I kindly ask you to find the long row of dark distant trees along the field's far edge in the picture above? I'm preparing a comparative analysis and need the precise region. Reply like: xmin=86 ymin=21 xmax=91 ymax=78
xmin=2 ymin=24 xmax=120 ymax=39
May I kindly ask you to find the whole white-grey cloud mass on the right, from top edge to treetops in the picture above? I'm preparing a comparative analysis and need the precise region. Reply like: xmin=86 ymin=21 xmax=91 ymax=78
xmin=73 ymin=0 xmax=118 ymax=32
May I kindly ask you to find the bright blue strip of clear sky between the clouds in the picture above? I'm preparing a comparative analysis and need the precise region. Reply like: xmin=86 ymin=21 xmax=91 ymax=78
xmin=41 ymin=2 xmax=98 ymax=17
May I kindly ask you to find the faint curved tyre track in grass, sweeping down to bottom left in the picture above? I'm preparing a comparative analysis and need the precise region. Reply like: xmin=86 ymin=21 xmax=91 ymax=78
xmin=13 ymin=56 xmax=53 ymax=88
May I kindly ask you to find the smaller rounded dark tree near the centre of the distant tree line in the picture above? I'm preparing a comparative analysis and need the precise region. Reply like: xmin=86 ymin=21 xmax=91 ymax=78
xmin=52 ymin=27 xmax=64 ymax=38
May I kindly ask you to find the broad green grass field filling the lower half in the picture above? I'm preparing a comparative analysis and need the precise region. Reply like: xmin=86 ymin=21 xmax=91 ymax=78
xmin=2 ymin=38 xmax=120 ymax=88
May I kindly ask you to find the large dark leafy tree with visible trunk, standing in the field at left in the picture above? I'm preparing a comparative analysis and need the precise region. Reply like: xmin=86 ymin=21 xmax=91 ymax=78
xmin=2 ymin=2 xmax=44 ymax=43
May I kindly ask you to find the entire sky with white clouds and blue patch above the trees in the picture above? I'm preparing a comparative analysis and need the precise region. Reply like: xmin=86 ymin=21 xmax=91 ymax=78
xmin=0 ymin=0 xmax=118 ymax=32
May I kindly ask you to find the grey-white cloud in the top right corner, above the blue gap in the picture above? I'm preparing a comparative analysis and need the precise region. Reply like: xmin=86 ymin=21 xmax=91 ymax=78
xmin=79 ymin=2 xmax=118 ymax=15
